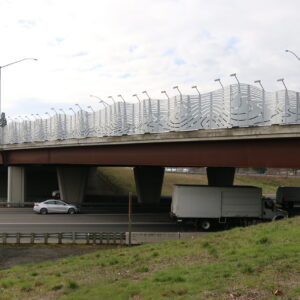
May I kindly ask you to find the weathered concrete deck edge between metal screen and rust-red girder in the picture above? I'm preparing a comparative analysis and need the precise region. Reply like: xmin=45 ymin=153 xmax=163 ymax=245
xmin=0 ymin=124 xmax=300 ymax=151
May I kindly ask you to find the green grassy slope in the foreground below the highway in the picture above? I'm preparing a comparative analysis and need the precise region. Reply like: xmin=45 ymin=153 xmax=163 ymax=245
xmin=0 ymin=218 xmax=300 ymax=300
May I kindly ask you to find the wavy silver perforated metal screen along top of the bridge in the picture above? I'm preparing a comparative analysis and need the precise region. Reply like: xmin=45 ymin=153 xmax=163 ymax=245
xmin=0 ymin=84 xmax=300 ymax=145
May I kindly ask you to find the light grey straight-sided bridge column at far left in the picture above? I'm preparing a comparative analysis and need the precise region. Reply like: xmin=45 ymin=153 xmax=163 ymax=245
xmin=7 ymin=166 xmax=26 ymax=206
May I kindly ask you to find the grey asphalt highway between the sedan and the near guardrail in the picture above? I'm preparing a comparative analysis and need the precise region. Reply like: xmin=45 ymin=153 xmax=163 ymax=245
xmin=0 ymin=208 xmax=180 ymax=233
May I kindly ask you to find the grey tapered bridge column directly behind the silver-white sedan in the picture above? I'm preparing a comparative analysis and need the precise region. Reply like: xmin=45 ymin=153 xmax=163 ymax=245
xmin=57 ymin=166 xmax=88 ymax=203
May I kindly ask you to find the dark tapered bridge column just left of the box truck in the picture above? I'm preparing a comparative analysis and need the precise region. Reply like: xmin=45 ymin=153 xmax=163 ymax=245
xmin=134 ymin=166 xmax=165 ymax=203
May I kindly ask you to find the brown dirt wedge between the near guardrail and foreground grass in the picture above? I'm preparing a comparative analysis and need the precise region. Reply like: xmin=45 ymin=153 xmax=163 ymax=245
xmin=0 ymin=245 xmax=115 ymax=270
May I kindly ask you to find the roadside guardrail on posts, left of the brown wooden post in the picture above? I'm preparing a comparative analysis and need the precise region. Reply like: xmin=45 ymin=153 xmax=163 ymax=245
xmin=0 ymin=232 xmax=126 ymax=245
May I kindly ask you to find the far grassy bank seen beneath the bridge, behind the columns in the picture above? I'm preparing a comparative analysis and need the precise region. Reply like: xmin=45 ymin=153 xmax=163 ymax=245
xmin=99 ymin=167 xmax=300 ymax=195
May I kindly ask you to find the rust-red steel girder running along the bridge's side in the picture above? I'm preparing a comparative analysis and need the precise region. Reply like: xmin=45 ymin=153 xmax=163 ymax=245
xmin=0 ymin=138 xmax=300 ymax=168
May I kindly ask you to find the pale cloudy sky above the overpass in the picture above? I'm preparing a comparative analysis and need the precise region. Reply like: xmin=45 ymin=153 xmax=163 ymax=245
xmin=0 ymin=0 xmax=300 ymax=116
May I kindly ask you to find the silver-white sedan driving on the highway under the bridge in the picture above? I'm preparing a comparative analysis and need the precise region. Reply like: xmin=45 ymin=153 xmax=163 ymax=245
xmin=33 ymin=199 xmax=79 ymax=215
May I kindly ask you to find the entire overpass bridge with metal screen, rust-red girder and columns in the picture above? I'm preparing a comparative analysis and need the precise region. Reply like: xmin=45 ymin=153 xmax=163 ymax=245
xmin=0 ymin=84 xmax=300 ymax=206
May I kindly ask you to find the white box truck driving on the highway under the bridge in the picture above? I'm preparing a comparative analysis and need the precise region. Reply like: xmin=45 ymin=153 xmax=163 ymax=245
xmin=171 ymin=184 xmax=288 ymax=230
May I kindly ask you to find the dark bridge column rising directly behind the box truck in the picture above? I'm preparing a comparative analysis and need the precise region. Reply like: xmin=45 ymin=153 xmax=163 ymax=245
xmin=206 ymin=167 xmax=235 ymax=186
